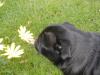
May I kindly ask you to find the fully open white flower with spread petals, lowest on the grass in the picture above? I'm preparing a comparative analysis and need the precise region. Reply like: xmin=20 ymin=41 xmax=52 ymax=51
xmin=1 ymin=43 xmax=24 ymax=59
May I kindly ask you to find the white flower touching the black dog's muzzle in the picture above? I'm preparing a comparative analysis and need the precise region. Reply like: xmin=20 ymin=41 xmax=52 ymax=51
xmin=18 ymin=26 xmax=35 ymax=44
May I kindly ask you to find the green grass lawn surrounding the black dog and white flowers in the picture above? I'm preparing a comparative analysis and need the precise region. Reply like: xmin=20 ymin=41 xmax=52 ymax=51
xmin=0 ymin=0 xmax=100 ymax=75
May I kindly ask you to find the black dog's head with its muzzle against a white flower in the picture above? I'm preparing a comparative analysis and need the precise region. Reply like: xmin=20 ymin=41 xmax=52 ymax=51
xmin=35 ymin=25 xmax=71 ymax=65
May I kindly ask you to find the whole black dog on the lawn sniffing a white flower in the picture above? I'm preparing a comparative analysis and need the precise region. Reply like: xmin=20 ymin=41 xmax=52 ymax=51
xmin=35 ymin=23 xmax=100 ymax=75
